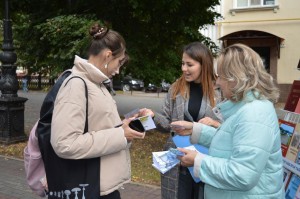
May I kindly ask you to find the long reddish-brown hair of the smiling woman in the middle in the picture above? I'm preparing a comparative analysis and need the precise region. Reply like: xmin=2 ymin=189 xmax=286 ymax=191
xmin=172 ymin=42 xmax=216 ymax=107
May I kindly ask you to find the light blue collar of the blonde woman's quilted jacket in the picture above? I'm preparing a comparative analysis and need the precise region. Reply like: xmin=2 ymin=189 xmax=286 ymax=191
xmin=217 ymin=91 xmax=258 ymax=120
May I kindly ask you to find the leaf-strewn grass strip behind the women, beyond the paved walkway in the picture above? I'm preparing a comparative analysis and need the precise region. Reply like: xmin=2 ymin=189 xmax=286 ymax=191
xmin=0 ymin=130 xmax=169 ymax=186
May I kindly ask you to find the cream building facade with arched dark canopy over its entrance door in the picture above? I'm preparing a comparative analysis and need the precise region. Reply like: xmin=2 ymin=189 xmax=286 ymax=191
xmin=204 ymin=0 xmax=300 ymax=102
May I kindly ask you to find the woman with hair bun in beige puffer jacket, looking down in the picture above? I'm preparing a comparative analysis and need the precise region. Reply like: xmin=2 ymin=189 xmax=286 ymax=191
xmin=51 ymin=24 xmax=144 ymax=199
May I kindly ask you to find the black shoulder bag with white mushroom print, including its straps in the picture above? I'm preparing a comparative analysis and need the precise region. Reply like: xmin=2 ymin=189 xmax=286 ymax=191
xmin=36 ymin=70 xmax=100 ymax=199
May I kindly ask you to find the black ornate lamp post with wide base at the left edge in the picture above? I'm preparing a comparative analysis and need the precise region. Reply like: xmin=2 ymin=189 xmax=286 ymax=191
xmin=0 ymin=0 xmax=27 ymax=144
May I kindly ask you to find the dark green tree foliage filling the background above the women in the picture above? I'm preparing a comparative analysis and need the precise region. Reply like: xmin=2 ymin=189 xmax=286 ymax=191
xmin=7 ymin=0 xmax=219 ymax=83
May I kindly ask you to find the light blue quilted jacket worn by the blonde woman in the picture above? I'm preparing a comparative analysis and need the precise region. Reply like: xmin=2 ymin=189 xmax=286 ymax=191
xmin=191 ymin=92 xmax=284 ymax=199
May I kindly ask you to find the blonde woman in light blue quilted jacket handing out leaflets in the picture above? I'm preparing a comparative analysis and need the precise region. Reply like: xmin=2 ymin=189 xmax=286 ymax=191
xmin=174 ymin=44 xmax=284 ymax=199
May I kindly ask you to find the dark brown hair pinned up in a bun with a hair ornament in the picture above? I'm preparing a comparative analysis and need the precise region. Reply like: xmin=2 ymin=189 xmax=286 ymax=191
xmin=88 ymin=23 xmax=126 ymax=57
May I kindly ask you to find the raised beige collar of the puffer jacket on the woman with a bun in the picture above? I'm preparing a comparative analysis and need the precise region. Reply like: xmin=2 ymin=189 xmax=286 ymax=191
xmin=72 ymin=55 xmax=109 ymax=84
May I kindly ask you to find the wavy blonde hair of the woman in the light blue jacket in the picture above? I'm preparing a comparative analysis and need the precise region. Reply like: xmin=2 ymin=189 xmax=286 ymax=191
xmin=217 ymin=44 xmax=279 ymax=103
